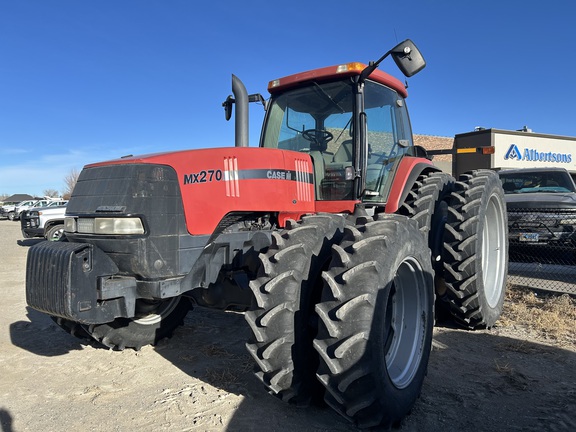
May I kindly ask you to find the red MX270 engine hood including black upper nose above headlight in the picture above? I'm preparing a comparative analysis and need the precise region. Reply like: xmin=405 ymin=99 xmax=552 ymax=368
xmin=80 ymin=147 xmax=315 ymax=235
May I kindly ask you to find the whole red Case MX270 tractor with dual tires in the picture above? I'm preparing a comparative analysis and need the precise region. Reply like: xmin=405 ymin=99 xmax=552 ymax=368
xmin=26 ymin=40 xmax=508 ymax=427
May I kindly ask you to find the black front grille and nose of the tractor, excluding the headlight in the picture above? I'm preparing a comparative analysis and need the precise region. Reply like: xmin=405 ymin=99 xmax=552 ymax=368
xmin=66 ymin=163 xmax=188 ymax=279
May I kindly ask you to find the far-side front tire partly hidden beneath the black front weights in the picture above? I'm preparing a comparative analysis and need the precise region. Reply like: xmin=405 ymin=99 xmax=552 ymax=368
xmin=82 ymin=296 xmax=192 ymax=351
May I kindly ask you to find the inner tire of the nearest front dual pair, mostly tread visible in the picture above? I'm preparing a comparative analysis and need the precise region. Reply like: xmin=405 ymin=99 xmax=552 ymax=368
xmin=244 ymin=214 xmax=344 ymax=406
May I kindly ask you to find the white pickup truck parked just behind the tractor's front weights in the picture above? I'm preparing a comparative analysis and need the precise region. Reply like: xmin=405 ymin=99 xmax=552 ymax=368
xmin=20 ymin=205 xmax=66 ymax=241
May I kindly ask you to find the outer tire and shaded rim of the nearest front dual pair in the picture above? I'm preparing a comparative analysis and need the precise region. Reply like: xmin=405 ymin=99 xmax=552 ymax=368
xmin=314 ymin=215 xmax=434 ymax=428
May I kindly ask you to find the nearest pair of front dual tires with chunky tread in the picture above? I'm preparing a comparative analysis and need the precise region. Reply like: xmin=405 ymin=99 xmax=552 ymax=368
xmin=245 ymin=215 xmax=434 ymax=427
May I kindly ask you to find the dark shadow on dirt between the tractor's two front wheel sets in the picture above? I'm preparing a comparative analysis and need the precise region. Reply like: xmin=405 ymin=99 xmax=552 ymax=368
xmin=155 ymin=307 xmax=358 ymax=432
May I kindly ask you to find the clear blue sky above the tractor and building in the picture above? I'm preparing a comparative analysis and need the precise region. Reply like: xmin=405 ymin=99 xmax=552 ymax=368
xmin=0 ymin=0 xmax=576 ymax=195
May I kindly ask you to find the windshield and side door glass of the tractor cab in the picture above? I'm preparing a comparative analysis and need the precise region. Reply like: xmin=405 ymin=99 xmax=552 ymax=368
xmin=262 ymin=80 xmax=412 ymax=202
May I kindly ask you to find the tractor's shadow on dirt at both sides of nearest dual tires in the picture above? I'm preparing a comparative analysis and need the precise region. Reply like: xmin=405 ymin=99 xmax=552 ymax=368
xmin=156 ymin=308 xmax=576 ymax=432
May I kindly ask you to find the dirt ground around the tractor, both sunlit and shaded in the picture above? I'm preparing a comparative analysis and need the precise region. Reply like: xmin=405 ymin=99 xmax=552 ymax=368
xmin=0 ymin=220 xmax=576 ymax=432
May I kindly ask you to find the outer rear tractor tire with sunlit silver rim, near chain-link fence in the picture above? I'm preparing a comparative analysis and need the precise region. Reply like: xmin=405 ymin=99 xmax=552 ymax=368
xmin=444 ymin=170 xmax=508 ymax=329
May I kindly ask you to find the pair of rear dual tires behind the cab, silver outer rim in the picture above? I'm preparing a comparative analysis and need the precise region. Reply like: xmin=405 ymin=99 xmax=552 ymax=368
xmin=399 ymin=170 xmax=508 ymax=329
